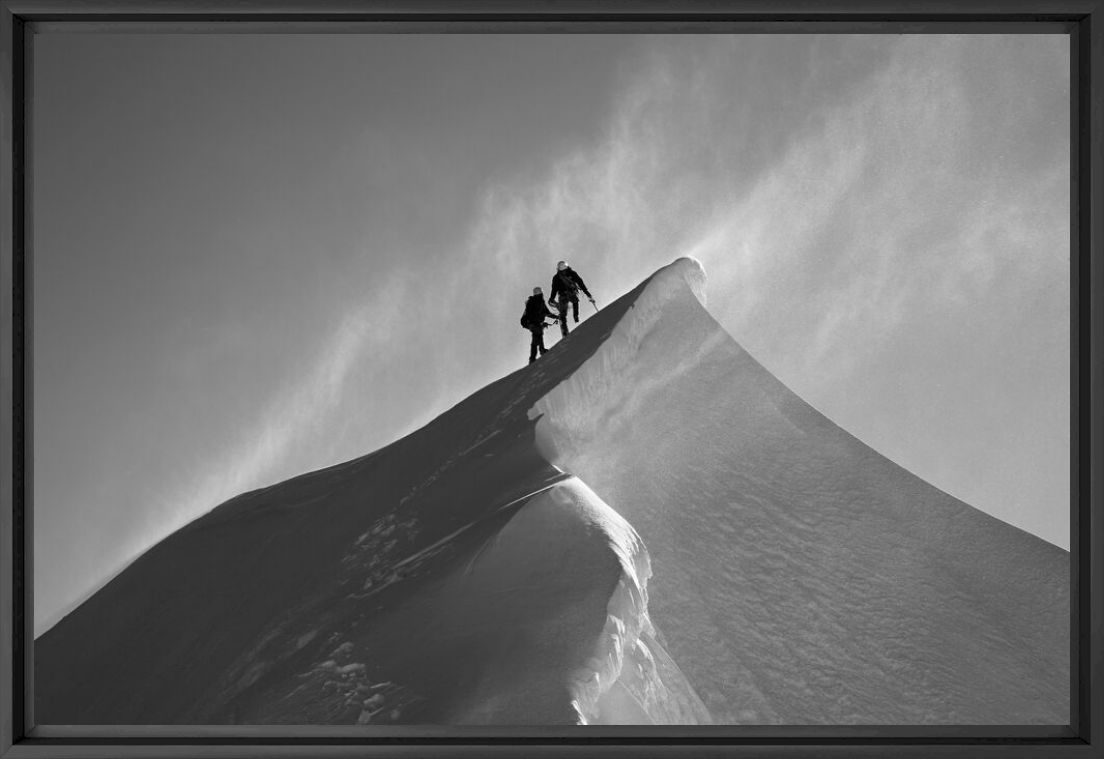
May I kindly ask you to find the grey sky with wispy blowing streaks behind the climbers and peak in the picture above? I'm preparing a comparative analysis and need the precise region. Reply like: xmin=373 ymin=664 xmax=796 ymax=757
xmin=33 ymin=34 xmax=1070 ymax=631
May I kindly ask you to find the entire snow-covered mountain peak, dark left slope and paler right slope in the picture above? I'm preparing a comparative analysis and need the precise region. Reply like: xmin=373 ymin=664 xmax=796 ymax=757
xmin=35 ymin=258 xmax=1070 ymax=725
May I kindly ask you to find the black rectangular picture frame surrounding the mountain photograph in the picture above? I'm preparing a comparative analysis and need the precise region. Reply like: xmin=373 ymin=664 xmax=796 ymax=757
xmin=0 ymin=0 xmax=1104 ymax=759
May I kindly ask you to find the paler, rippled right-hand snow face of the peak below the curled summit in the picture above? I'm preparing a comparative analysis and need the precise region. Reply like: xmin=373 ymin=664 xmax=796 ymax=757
xmin=532 ymin=259 xmax=1069 ymax=724
